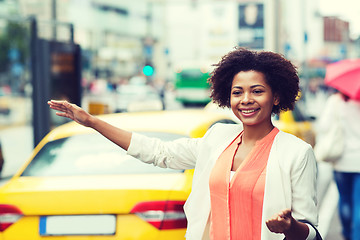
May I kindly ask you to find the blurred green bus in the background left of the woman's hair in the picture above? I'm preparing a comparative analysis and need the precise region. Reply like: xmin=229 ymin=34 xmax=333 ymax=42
xmin=174 ymin=64 xmax=211 ymax=106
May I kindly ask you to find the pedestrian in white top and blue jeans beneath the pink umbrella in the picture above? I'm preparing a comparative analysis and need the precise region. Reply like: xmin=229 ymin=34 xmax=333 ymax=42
xmin=315 ymin=92 xmax=360 ymax=240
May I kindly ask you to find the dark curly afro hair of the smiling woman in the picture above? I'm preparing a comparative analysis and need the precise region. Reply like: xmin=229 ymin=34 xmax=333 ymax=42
xmin=208 ymin=48 xmax=300 ymax=114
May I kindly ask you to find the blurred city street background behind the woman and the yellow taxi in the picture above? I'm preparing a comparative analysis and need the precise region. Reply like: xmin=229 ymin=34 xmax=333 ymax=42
xmin=0 ymin=0 xmax=360 ymax=240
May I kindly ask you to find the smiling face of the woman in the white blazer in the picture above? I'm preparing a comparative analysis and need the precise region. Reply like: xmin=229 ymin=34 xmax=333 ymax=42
xmin=230 ymin=71 xmax=279 ymax=127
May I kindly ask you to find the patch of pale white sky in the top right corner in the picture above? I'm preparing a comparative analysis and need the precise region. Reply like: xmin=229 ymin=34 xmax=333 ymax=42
xmin=319 ymin=0 xmax=360 ymax=38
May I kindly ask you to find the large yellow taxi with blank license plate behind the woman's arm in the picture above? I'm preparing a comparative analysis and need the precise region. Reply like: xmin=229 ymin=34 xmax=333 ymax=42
xmin=0 ymin=109 xmax=233 ymax=240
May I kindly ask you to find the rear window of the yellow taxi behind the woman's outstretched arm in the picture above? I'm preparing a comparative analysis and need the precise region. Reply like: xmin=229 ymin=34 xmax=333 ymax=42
xmin=21 ymin=132 xmax=184 ymax=176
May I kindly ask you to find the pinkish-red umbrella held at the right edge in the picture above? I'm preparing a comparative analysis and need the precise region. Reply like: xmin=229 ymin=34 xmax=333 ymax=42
xmin=325 ymin=59 xmax=360 ymax=100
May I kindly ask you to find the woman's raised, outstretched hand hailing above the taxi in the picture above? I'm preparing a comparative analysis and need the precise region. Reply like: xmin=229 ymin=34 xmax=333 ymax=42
xmin=48 ymin=100 xmax=92 ymax=127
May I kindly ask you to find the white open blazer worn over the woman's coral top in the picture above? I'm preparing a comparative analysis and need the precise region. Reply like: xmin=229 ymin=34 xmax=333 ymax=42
xmin=128 ymin=124 xmax=318 ymax=240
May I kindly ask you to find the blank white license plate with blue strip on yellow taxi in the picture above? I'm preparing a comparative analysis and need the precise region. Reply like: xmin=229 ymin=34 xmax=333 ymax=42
xmin=39 ymin=215 xmax=116 ymax=236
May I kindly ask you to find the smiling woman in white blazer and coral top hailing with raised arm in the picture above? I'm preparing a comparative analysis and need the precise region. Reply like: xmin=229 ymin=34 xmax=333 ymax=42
xmin=49 ymin=48 xmax=321 ymax=240
